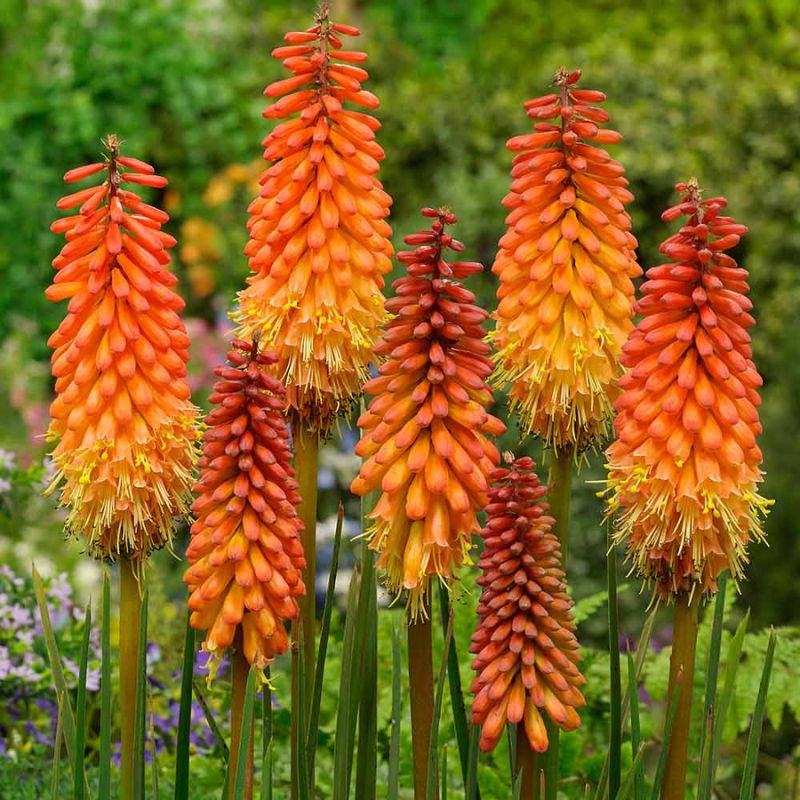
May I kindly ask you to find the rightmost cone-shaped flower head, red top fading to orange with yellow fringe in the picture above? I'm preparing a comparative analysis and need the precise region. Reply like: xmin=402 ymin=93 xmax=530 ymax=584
xmin=607 ymin=181 xmax=768 ymax=595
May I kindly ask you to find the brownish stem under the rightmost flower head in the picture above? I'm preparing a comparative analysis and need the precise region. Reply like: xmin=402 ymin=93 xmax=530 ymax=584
xmin=661 ymin=592 xmax=700 ymax=800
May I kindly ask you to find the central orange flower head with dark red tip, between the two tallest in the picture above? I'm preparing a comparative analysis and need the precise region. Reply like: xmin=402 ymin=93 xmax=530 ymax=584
xmin=351 ymin=208 xmax=505 ymax=615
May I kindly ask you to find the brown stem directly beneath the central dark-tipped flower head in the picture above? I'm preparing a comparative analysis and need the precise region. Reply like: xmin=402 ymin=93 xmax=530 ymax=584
xmin=408 ymin=595 xmax=433 ymax=800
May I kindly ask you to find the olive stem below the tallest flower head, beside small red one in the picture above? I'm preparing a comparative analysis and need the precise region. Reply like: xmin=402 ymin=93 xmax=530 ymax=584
xmin=291 ymin=419 xmax=319 ymax=800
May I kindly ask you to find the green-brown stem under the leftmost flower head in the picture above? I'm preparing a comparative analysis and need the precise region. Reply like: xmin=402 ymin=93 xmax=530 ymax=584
xmin=119 ymin=556 xmax=142 ymax=800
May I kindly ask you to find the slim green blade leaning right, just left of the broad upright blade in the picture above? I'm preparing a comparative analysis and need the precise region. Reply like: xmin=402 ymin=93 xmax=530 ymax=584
xmin=333 ymin=556 xmax=361 ymax=800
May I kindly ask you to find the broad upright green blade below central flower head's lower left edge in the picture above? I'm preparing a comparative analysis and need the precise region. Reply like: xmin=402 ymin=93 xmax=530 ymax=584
xmin=356 ymin=542 xmax=378 ymax=800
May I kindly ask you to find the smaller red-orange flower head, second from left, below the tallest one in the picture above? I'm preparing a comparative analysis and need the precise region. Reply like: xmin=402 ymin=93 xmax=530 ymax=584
xmin=183 ymin=341 xmax=305 ymax=668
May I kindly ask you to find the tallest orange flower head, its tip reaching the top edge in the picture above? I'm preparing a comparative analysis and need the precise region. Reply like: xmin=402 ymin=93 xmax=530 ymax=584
xmin=234 ymin=6 xmax=392 ymax=432
